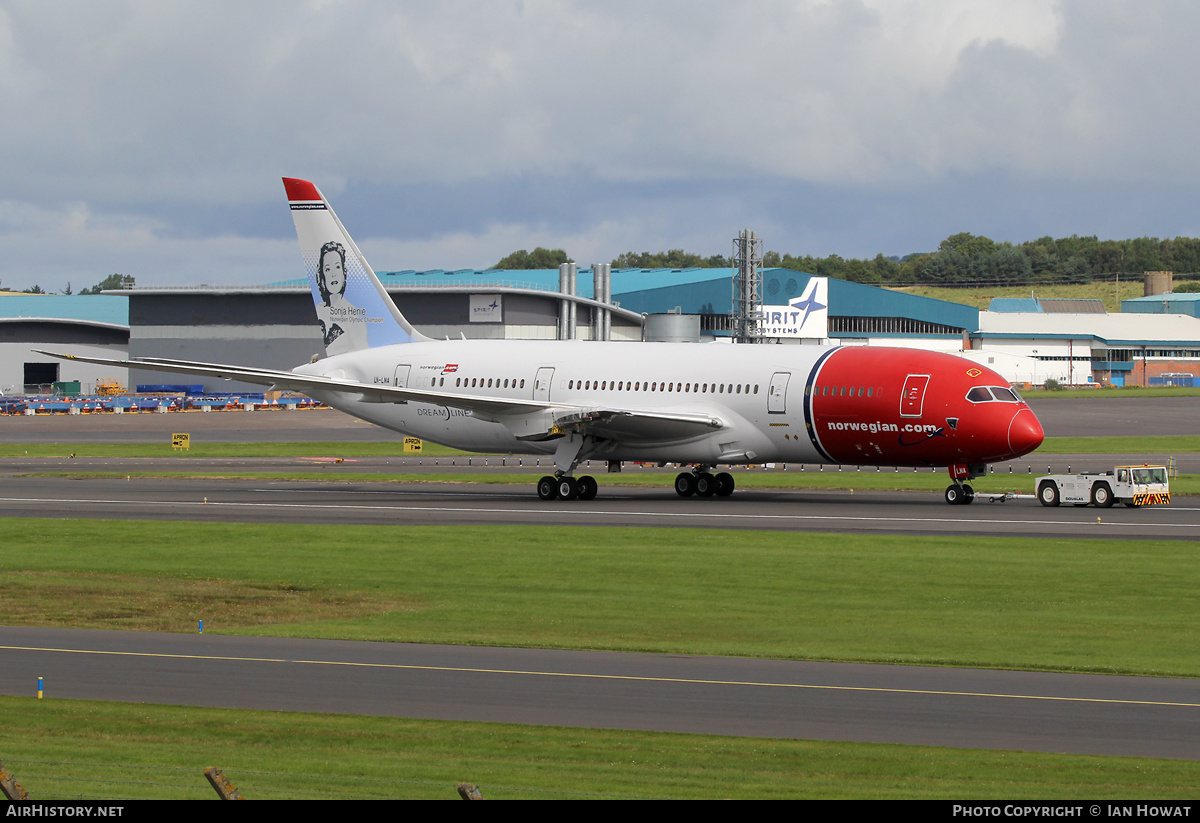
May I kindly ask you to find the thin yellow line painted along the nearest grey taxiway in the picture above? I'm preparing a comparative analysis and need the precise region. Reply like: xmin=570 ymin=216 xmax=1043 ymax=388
xmin=0 ymin=645 xmax=1200 ymax=709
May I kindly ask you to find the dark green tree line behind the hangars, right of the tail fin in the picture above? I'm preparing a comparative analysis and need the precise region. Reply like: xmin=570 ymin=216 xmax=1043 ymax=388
xmin=492 ymin=232 xmax=1200 ymax=287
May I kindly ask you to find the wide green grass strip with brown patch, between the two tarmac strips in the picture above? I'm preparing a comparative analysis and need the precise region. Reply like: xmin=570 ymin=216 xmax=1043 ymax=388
xmin=0 ymin=518 xmax=1200 ymax=677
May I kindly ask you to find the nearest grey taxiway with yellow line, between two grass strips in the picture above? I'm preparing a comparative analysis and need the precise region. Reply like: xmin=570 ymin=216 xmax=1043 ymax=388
xmin=0 ymin=627 xmax=1200 ymax=759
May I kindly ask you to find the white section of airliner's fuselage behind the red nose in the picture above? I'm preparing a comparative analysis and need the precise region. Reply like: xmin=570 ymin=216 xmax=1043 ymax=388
xmin=295 ymin=341 xmax=830 ymax=463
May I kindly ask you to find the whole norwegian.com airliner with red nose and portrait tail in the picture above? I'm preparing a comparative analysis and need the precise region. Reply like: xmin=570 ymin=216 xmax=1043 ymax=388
xmin=44 ymin=178 xmax=1043 ymax=504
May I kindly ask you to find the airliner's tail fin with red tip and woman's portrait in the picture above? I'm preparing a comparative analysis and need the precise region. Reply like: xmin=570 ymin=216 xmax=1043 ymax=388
xmin=283 ymin=178 xmax=428 ymax=354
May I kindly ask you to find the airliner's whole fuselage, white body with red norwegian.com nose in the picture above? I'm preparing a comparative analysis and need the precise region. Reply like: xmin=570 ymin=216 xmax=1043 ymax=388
xmin=295 ymin=341 xmax=1043 ymax=474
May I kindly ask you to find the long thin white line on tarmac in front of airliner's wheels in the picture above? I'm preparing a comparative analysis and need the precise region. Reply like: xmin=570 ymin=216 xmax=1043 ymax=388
xmin=0 ymin=497 xmax=1200 ymax=529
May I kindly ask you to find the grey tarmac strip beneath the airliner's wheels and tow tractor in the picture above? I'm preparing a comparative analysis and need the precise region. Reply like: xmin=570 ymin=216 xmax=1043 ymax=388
xmin=0 ymin=473 xmax=1200 ymax=541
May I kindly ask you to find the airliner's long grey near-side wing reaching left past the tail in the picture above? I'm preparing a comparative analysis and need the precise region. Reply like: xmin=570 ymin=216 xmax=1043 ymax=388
xmin=36 ymin=349 xmax=724 ymax=441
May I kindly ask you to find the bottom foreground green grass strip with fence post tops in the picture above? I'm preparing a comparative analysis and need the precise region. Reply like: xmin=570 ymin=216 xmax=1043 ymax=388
xmin=0 ymin=697 xmax=1200 ymax=801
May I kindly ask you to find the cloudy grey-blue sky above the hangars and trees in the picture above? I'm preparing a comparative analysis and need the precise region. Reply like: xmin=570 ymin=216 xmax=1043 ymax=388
xmin=0 ymin=0 xmax=1200 ymax=292
